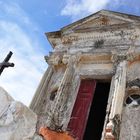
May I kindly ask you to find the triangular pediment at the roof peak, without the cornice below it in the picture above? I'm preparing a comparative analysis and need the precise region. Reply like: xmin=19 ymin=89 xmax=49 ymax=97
xmin=62 ymin=10 xmax=140 ymax=34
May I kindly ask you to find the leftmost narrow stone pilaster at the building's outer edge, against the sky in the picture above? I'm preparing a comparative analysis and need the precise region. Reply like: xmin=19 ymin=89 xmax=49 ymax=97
xmin=30 ymin=66 xmax=53 ymax=113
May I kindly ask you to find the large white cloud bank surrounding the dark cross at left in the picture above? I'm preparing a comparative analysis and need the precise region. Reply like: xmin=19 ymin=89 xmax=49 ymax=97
xmin=0 ymin=3 xmax=47 ymax=105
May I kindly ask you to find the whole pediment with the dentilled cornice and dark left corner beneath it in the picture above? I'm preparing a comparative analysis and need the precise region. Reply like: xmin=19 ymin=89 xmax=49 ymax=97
xmin=46 ymin=10 xmax=140 ymax=48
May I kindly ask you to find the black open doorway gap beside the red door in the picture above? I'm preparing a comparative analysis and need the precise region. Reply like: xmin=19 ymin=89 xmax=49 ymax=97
xmin=83 ymin=82 xmax=110 ymax=140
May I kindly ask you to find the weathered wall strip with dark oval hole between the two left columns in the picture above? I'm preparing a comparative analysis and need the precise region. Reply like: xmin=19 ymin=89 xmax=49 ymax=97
xmin=37 ymin=67 xmax=65 ymax=128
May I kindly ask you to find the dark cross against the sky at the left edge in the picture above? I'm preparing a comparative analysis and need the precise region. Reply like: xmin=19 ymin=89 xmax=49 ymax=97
xmin=0 ymin=51 xmax=14 ymax=75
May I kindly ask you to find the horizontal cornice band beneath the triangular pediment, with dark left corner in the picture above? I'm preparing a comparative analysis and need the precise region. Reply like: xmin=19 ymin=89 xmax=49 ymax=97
xmin=46 ymin=24 xmax=140 ymax=48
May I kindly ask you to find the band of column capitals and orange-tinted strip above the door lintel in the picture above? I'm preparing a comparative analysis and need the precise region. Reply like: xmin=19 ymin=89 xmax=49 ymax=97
xmin=45 ymin=46 xmax=140 ymax=70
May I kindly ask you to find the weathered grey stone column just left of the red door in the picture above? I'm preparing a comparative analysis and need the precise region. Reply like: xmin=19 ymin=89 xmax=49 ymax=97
xmin=50 ymin=56 xmax=76 ymax=130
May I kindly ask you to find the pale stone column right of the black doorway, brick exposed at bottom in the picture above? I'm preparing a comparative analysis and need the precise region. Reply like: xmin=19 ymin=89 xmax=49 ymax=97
xmin=105 ymin=60 xmax=127 ymax=140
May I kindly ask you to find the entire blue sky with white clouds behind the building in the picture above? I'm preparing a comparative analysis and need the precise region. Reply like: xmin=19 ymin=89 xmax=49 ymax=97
xmin=0 ymin=0 xmax=140 ymax=105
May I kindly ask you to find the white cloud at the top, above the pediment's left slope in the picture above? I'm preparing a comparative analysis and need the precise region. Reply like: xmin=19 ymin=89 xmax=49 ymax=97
xmin=61 ymin=0 xmax=109 ymax=20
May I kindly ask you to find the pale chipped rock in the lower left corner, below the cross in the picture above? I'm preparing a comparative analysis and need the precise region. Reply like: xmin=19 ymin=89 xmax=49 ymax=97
xmin=0 ymin=88 xmax=37 ymax=140
